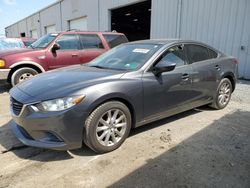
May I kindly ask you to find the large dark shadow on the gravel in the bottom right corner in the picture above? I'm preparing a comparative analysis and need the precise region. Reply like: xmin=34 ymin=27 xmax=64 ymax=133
xmin=110 ymin=110 xmax=250 ymax=188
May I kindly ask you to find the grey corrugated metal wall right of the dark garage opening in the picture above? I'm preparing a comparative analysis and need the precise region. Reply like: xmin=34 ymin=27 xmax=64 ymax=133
xmin=151 ymin=0 xmax=250 ymax=79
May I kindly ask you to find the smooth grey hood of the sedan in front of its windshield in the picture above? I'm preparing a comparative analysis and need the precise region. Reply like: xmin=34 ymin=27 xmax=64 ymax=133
xmin=13 ymin=65 xmax=124 ymax=103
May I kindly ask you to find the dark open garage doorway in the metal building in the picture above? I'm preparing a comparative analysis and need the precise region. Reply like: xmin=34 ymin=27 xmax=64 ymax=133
xmin=111 ymin=0 xmax=151 ymax=41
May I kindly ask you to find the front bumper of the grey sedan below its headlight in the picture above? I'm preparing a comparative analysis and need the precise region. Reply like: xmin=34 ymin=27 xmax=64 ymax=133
xmin=11 ymin=97 xmax=90 ymax=150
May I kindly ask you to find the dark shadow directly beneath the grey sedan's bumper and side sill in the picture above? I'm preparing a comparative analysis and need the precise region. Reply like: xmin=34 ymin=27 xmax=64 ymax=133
xmin=0 ymin=107 xmax=207 ymax=162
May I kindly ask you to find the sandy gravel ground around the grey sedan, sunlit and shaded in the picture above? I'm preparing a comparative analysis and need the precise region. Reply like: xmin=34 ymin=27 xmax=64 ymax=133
xmin=0 ymin=81 xmax=250 ymax=188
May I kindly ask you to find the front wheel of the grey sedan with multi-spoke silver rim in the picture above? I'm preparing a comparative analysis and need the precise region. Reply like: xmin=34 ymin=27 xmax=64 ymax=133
xmin=84 ymin=101 xmax=131 ymax=153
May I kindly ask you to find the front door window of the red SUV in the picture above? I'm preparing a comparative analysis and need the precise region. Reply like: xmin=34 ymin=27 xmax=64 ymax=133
xmin=57 ymin=34 xmax=79 ymax=50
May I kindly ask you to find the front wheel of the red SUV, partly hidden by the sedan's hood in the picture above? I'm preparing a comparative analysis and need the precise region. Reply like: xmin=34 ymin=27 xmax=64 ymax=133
xmin=11 ymin=67 xmax=38 ymax=86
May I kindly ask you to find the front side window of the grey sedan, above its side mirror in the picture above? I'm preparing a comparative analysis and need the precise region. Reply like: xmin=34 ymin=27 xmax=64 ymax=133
xmin=159 ymin=46 xmax=186 ymax=66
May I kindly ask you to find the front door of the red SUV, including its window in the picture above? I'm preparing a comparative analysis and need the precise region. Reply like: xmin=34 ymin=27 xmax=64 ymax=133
xmin=46 ymin=34 xmax=81 ymax=69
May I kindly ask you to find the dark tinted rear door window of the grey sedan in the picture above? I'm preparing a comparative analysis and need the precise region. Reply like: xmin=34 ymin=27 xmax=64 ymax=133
xmin=185 ymin=44 xmax=210 ymax=62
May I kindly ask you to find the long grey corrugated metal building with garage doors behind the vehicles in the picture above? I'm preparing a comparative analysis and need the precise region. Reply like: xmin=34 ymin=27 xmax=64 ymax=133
xmin=3 ymin=0 xmax=250 ymax=79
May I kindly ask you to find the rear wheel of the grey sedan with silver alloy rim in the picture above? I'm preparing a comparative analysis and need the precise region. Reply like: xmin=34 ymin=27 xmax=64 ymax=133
xmin=210 ymin=78 xmax=233 ymax=110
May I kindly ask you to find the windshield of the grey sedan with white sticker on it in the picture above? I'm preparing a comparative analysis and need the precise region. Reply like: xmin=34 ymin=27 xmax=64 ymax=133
xmin=88 ymin=44 xmax=162 ymax=71
